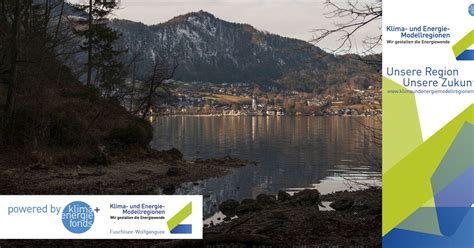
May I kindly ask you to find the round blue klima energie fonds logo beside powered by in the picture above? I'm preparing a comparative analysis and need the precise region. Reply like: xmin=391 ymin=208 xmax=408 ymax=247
xmin=62 ymin=201 xmax=94 ymax=234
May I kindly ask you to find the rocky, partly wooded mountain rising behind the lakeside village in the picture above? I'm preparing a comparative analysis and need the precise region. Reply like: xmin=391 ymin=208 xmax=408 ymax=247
xmin=110 ymin=11 xmax=378 ymax=91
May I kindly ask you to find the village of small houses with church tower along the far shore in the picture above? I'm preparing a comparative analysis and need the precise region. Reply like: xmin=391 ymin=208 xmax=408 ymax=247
xmin=153 ymin=81 xmax=382 ymax=116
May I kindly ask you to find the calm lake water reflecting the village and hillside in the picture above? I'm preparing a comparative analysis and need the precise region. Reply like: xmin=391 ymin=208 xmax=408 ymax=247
xmin=152 ymin=116 xmax=381 ymax=217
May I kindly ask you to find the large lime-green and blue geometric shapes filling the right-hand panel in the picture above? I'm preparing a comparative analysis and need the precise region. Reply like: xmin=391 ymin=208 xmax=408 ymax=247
xmin=382 ymin=78 xmax=474 ymax=247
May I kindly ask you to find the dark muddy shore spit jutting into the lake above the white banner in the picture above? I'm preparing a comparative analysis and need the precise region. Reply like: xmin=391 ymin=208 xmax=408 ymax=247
xmin=0 ymin=149 xmax=256 ymax=195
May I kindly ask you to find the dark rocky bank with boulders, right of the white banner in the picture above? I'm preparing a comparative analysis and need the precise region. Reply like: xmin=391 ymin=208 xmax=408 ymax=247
xmin=161 ymin=188 xmax=382 ymax=247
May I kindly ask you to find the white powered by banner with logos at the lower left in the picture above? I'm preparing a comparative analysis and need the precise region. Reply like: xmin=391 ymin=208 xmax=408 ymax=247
xmin=0 ymin=195 xmax=202 ymax=239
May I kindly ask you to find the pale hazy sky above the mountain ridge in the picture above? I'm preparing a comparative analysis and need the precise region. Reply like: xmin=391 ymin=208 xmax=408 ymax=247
xmin=69 ymin=0 xmax=381 ymax=52
